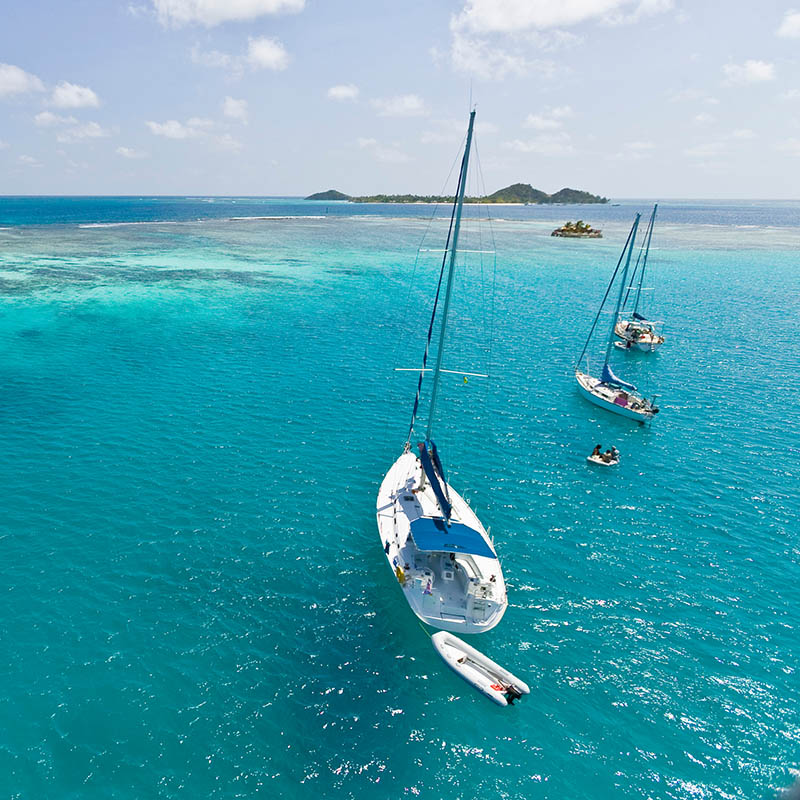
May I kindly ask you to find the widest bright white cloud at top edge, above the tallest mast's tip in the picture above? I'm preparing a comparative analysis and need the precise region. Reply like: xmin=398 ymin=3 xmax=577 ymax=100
xmin=451 ymin=0 xmax=672 ymax=34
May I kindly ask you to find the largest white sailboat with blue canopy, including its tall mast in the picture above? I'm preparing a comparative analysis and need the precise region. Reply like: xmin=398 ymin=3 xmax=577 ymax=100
xmin=377 ymin=111 xmax=508 ymax=633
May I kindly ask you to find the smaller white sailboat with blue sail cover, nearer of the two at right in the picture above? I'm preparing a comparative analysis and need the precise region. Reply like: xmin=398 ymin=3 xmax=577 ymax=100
xmin=575 ymin=214 xmax=658 ymax=422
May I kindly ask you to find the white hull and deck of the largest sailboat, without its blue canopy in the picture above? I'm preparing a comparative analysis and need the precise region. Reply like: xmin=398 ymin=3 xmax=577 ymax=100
xmin=377 ymin=452 xmax=508 ymax=633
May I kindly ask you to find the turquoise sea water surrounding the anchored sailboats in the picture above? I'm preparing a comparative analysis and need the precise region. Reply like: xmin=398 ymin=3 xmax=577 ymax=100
xmin=0 ymin=199 xmax=800 ymax=800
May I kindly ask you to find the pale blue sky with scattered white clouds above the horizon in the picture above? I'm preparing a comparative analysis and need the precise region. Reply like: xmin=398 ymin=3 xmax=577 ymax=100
xmin=0 ymin=0 xmax=800 ymax=199
